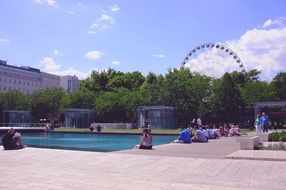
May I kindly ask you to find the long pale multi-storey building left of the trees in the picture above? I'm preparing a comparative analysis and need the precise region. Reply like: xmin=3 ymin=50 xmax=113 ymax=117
xmin=0 ymin=60 xmax=79 ymax=94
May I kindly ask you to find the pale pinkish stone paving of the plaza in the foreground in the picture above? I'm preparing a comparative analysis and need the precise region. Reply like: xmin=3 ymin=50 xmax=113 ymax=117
xmin=0 ymin=138 xmax=286 ymax=190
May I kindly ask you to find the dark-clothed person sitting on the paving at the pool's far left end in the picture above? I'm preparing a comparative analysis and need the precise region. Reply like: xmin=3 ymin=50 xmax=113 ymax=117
xmin=2 ymin=128 xmax=26 ymax=150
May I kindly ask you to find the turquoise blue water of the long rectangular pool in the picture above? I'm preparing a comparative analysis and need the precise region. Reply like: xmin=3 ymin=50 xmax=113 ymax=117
xmin=19 ymin=133 xmax=176 ymax=152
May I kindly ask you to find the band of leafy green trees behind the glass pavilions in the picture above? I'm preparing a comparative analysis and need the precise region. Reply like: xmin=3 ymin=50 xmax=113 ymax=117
xmin=0 ymin=68 xmax=286 ymax=123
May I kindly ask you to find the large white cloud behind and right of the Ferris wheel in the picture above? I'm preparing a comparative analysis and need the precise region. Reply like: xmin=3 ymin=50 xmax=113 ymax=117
xmin=183 ymin=18 xmax=286 ymax=80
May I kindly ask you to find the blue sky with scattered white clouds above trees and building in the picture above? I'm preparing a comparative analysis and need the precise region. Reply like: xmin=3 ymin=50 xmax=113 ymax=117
xmin=0 ymin=0 xmax=286 ymax=80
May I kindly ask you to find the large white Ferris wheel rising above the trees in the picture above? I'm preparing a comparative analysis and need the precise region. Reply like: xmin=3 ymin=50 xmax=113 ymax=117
xmin=182 ymin=43 xmax=245 ymax=78
